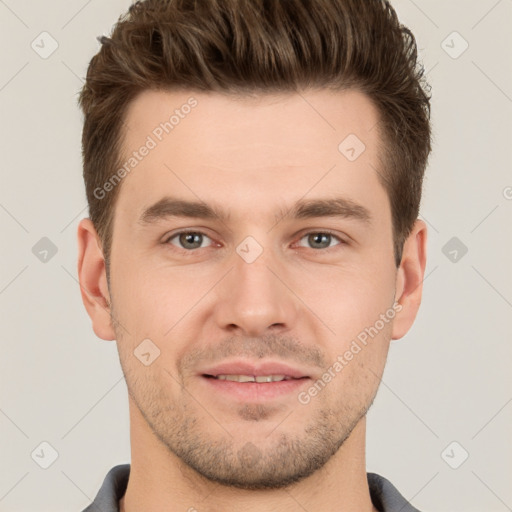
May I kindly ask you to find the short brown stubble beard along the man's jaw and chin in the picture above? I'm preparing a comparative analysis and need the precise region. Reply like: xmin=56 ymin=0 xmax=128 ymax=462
xmin=119 ymin=350 xmax=375 ymax=490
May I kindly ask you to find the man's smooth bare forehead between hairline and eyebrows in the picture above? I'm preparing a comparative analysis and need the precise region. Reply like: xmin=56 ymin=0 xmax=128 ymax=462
xmin=118 ymin=90 xmax=383 ymax=228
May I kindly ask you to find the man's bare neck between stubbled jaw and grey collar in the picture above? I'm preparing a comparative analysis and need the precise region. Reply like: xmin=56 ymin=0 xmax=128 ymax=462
xmin=119 ymin=403 xmax=378 ymax=512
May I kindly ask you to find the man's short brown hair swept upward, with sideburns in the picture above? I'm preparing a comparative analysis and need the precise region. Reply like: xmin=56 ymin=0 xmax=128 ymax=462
xmin=79 ymin=0 xmax=431 ymax=273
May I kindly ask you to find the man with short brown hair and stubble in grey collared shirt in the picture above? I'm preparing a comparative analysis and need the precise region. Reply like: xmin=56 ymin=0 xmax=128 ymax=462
xmin=78 ymin=0 xmax=430 ymax=512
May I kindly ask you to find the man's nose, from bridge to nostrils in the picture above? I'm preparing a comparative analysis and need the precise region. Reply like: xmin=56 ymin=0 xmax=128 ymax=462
xmin=215 ymin=242 xmax=299 ymax=337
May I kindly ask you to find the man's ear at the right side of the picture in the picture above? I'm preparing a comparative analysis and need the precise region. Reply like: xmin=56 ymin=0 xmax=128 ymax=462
xmin=392 ymin=219 xmax=427 ymax=340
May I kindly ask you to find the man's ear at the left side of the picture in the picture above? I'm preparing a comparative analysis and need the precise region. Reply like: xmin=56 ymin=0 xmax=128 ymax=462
xmin=77 ymin=219 xmax=115 ymax=341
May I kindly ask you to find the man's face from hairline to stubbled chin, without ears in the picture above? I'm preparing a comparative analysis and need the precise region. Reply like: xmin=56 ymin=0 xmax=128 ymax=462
xmin=99 ymin=90 xmax=400 ymax=489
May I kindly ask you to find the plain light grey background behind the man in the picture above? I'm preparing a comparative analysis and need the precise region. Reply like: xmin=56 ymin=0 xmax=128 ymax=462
xmin=0 ymin=0 xmax=512 ymax=512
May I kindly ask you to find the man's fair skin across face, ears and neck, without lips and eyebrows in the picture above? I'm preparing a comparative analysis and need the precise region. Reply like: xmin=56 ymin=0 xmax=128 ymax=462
xmin=78 ymin=90 xmax=427 ymax=512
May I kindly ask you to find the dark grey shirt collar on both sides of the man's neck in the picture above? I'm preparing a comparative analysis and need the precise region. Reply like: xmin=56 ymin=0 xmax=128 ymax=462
xmin=83 ymin=464 xmax=419 ymax=512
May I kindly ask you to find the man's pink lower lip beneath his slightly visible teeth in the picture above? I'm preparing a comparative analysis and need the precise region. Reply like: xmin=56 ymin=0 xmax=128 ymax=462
xmin=201 ymin=376 xmax=311 ymax=402
